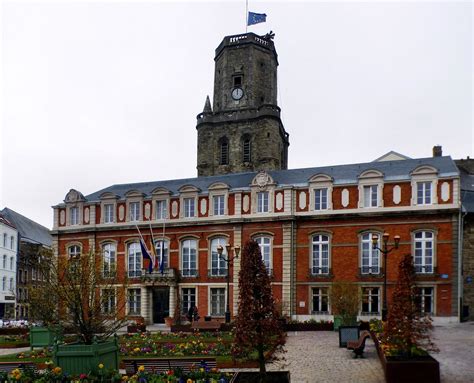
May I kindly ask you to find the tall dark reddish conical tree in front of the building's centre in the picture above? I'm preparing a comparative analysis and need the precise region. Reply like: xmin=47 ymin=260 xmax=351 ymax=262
xmin=233 ymin=240 xmax=285 ymax=381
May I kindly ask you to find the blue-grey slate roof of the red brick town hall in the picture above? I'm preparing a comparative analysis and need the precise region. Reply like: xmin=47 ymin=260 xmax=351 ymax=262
xmin=82 ymin=156 xmax=459 ymax=205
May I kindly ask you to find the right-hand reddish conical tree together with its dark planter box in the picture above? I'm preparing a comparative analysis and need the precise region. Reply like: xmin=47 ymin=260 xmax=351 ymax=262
xmin=372 ymin=254 xmax=440 ymax=383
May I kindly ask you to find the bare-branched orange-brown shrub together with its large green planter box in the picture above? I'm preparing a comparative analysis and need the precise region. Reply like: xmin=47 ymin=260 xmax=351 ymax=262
xmin=30 ymin=252 xmax=126 ymax=374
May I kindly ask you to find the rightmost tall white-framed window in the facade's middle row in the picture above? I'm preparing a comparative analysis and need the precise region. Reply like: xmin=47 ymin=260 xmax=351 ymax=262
xmin=412 ymin=230 xmax=436 ymax=274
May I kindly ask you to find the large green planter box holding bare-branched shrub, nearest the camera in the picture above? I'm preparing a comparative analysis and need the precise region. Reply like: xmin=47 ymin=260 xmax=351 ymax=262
xmin=53 ymin=337 xmax=119 ymax=375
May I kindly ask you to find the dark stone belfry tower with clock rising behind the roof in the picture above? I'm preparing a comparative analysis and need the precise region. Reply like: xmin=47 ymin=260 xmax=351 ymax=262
xmin=196 ymin=33 xmax=289 ymax=176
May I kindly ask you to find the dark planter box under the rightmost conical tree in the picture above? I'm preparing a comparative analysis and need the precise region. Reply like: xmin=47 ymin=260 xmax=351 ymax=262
xmin=372 ymin=335 xmax=440 ymax=383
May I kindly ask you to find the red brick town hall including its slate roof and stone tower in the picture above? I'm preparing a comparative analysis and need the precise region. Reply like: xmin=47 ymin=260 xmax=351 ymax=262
xmin=52 ymin=33 xmax=462 ymax=323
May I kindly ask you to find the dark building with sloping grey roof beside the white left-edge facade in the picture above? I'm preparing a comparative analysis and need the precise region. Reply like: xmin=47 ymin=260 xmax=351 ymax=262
xmin=0 ymin=208 xmax=52 ymax=319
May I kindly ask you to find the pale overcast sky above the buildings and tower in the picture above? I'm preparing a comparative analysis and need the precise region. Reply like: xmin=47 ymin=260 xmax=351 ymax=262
xmin=0 ymin=0 xmax=474 ymax=227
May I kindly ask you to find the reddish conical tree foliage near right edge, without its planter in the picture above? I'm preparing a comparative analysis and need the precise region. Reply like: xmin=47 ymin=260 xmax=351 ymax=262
xmin=384 ymin=254 xmax=437 ymax=357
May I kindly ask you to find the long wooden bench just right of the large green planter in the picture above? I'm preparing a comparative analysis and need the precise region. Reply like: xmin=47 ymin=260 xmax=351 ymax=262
xmin=122 ymin=358 xmax=217 ymax=375
